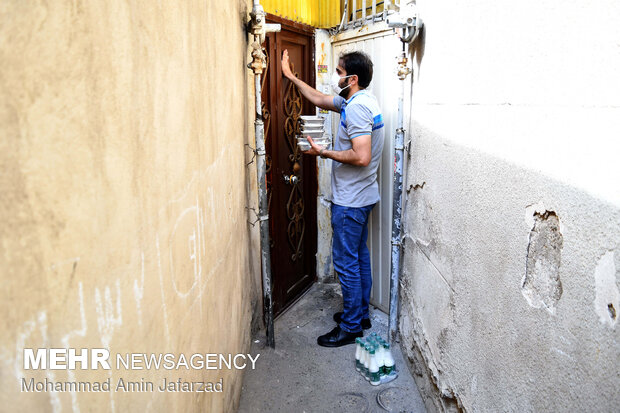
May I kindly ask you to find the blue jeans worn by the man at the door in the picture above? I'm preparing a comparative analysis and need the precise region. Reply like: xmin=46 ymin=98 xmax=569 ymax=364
xmin=332 ymin=204 xmax=375 ymax=333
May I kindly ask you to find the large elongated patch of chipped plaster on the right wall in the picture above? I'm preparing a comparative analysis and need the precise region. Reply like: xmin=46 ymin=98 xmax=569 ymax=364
xmin=521 ymin=208 xmax=564 ymax=314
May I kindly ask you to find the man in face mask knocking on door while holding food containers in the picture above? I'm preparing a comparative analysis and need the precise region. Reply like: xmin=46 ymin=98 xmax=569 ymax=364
xmin=282 ymin=50 xmax=384 ymax=347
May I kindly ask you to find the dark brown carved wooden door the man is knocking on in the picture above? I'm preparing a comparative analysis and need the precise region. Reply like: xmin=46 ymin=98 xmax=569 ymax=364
xmin=262 ymin=16 xmax=317 ymax=315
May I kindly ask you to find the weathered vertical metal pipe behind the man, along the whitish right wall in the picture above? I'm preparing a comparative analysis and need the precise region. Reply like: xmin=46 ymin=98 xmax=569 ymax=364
xmin=388 ymin=43 xmax=411 ymax=343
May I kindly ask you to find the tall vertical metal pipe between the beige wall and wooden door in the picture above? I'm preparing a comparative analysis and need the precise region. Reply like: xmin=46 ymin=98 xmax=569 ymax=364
xmin=248 ymin=0 xmax=280 ymax=348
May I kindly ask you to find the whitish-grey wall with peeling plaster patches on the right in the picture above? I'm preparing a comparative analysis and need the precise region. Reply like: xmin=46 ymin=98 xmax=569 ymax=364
xmin=400 ymin=0 xmax=620 ymax=412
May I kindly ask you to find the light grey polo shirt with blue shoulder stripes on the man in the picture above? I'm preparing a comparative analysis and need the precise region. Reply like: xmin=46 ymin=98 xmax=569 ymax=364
xmin=332 ymin=90 xmax=385 ymax=208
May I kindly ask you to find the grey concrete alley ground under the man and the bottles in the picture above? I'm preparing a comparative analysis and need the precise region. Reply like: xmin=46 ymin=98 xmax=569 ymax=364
xmin=239 ymin=284 xmax=426 ymax=413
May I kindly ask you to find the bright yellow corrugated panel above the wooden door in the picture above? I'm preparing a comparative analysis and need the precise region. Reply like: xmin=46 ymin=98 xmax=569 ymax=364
xmin=261 ymin=0 xmax=342 ymax=28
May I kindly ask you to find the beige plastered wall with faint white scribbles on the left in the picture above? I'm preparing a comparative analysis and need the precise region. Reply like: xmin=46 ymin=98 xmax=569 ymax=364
xmin=0 ymin=0 xmax=260 ymax=412
